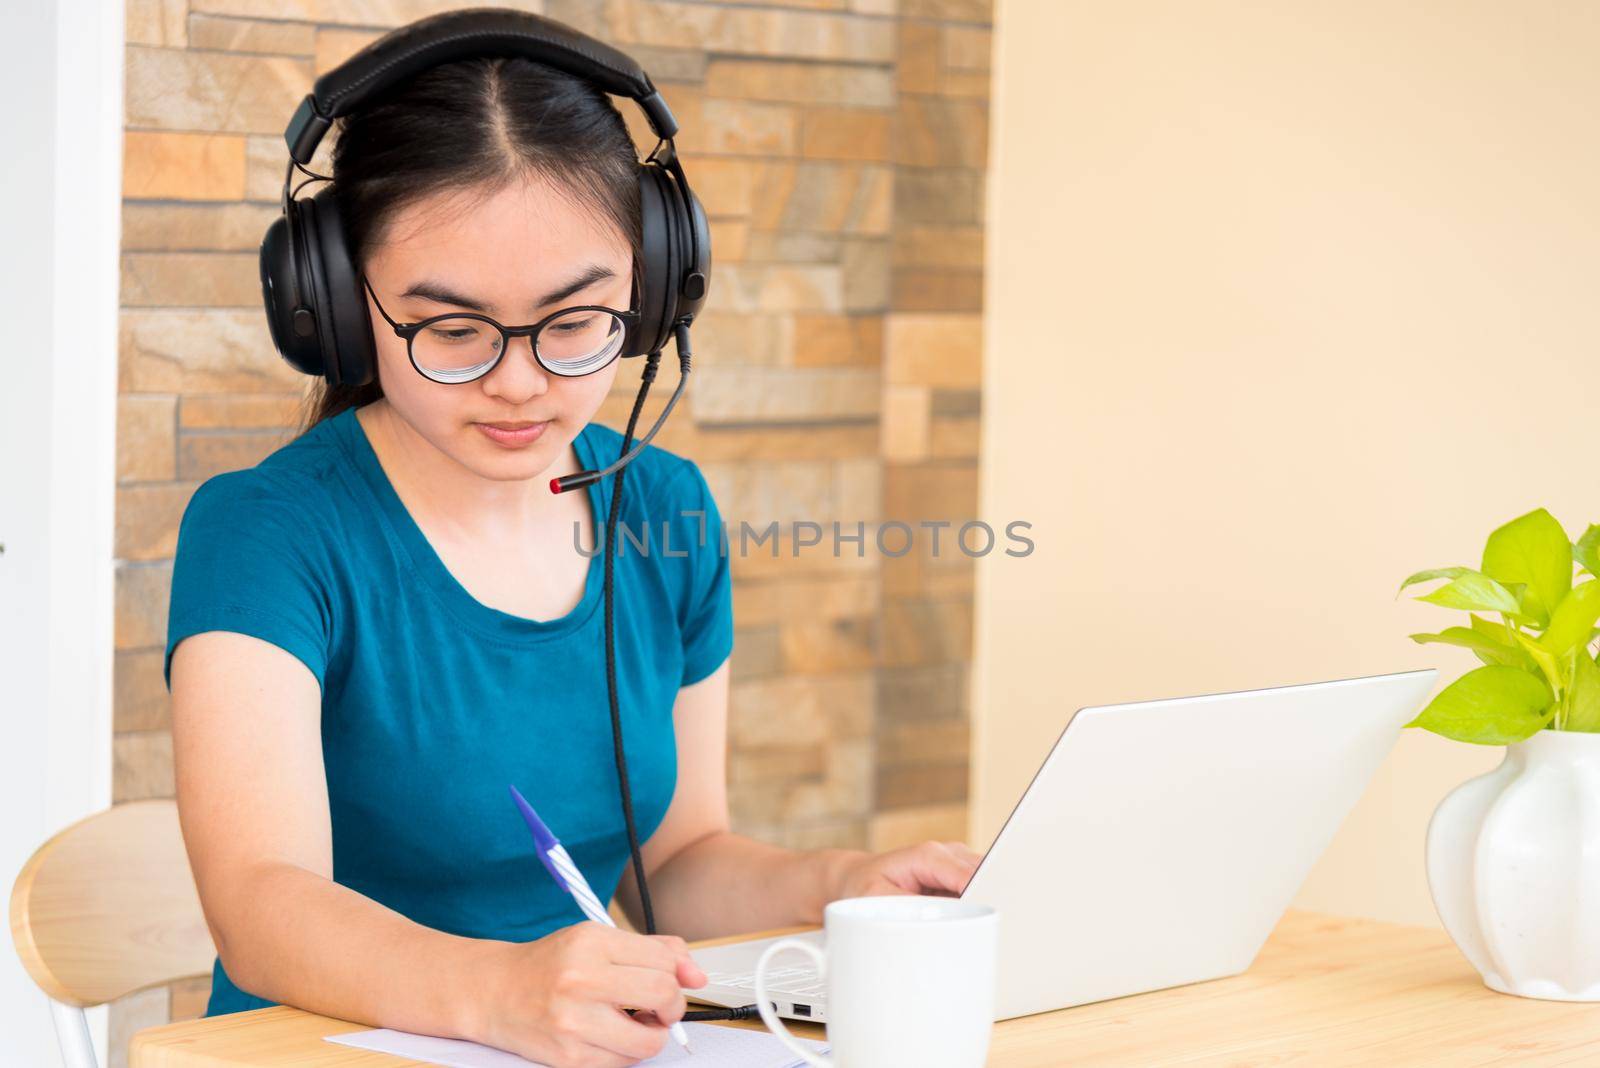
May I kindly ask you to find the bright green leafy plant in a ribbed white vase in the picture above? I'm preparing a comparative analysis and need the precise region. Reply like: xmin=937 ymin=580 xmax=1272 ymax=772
xmin=1400 ymin=508 xmax=1600 ymax=1001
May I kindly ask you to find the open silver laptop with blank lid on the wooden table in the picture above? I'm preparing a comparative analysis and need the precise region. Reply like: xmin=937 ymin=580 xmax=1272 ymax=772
xmin=686 ymin=668 xmax=1438 ymax=1020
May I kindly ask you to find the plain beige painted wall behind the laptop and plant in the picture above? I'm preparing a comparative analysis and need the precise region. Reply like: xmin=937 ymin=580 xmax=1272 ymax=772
xmin=973 ymin=0 xmax=1600 ymax=923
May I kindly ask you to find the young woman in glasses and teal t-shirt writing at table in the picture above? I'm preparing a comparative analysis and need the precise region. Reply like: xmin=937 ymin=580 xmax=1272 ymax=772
xmin=166 ymin=51 xmax=978 ymax=1065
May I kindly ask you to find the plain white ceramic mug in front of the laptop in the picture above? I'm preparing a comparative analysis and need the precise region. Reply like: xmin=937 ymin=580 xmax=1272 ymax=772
xmin=755 ymin=894 xmax=1000 ymax=1068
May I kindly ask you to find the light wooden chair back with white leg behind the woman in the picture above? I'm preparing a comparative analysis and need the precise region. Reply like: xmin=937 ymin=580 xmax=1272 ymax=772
xmin=11 ymin=801 xmax=214 ymax=1068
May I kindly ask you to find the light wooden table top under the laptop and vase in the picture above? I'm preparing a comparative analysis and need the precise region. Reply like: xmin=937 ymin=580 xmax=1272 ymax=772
xmin=130 ymin=910 xmax=1600 ymax=1068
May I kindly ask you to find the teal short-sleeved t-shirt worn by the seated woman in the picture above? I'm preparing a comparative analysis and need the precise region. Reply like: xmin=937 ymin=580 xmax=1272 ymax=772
xmin=165 ymin=409 xmax=733 ymax=1015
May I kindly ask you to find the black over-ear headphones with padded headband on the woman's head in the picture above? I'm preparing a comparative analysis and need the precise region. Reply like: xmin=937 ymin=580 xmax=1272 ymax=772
xmin=261 ymin=8 xmax=710 ymax=385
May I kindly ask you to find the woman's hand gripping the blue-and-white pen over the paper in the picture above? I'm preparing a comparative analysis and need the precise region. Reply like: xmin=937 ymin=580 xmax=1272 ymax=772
xmin=474 ymin=919 xmax=706 ymax=1068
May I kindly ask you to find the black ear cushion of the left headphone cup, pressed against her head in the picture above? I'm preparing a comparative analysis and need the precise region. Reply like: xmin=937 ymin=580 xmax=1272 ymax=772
xmin=301 ymin=185 xmax=378 ymax=385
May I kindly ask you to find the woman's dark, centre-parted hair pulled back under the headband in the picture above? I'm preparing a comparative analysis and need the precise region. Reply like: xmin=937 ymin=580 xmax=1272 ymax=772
xmin=299 ymin=58 xmax=643 ymax=433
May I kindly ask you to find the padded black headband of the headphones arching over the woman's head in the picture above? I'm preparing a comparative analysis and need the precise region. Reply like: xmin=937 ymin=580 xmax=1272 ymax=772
xmin=283 ymin=8 xmax=678 ymax=165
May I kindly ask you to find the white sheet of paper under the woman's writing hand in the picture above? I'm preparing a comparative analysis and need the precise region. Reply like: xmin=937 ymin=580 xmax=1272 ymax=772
xmin=328 ymin=1023 xmax=827 ymax=1068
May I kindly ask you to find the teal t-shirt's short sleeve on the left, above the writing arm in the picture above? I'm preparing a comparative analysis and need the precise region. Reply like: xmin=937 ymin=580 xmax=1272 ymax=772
xmin=163 ymin=468 xmax=333 ymax=691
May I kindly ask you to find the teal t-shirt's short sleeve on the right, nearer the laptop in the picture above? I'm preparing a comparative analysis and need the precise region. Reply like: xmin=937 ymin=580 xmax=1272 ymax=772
xmin=669 ymin=460 xmax=733 ymax=686
